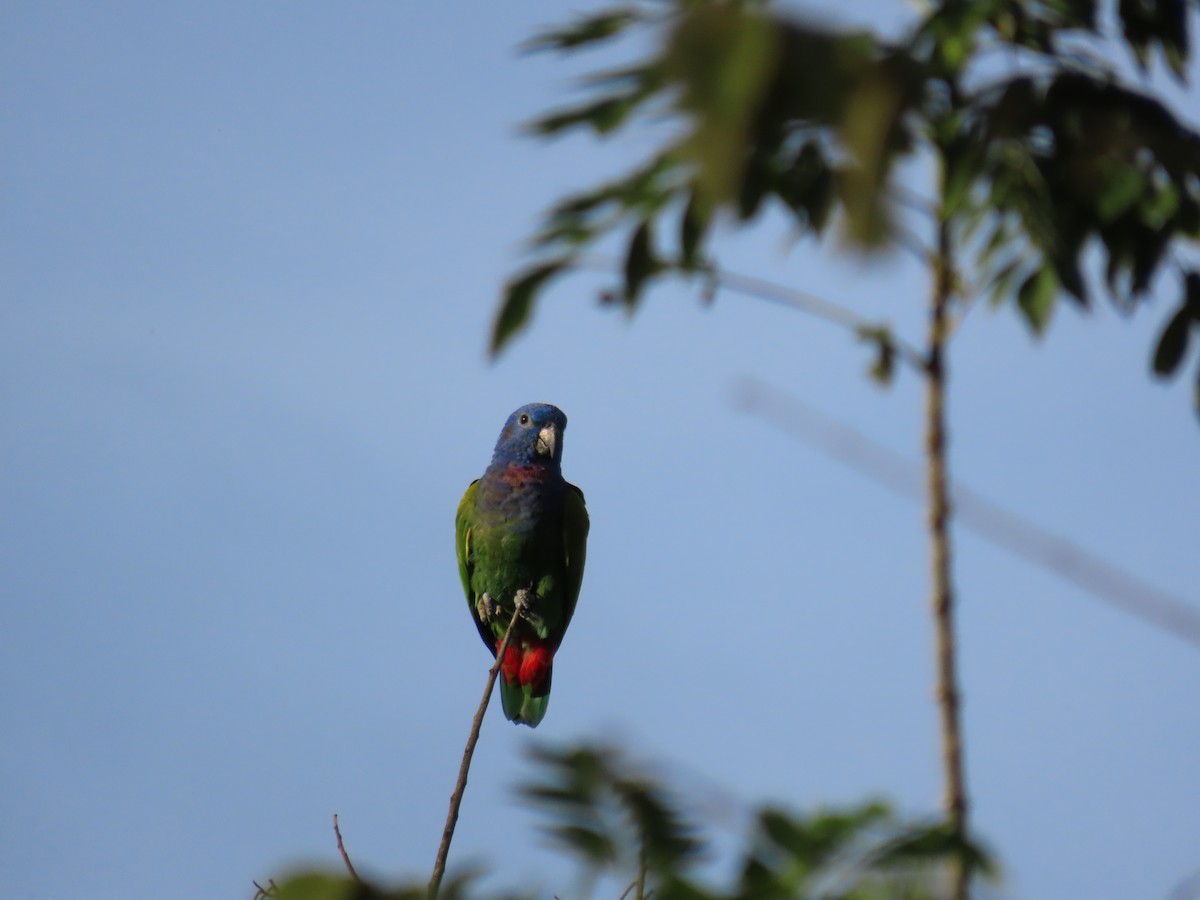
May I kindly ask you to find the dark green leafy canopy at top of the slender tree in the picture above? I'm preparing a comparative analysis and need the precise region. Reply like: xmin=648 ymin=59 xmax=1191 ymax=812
xmin=492 ymin=0 xmax=1200 ymax=422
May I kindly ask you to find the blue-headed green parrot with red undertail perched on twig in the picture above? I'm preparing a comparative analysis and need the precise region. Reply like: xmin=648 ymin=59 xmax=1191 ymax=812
xmin=455 ymin=403 xmax=590 ymax=728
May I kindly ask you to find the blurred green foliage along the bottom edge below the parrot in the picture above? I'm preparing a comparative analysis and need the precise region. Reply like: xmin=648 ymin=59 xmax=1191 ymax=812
xmin=267 ymin=744 xmax=996 ymax=900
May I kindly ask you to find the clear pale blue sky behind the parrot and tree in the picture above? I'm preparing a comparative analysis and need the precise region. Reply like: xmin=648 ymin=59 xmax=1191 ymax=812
xmin=0 ymin=2 xmax=1200 ymax=900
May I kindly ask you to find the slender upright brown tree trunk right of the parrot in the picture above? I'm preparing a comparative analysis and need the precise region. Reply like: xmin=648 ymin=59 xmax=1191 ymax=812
xmin=925 ymin=207 xmax=971 ymax=900
